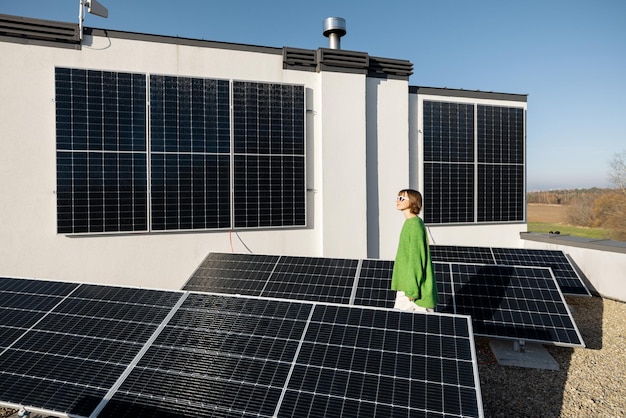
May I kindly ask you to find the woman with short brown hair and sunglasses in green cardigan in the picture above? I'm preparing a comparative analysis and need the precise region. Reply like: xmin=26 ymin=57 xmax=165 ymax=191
xmin=391 ymin=189 xmax=439 ymax=312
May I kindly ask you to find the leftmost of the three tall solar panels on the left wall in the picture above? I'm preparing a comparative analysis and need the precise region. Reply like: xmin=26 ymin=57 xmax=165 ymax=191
xmin=55 ymin=68 xmax=148 ymax=234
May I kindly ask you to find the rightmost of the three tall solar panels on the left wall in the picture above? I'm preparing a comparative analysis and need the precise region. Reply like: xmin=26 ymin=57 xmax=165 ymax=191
xmin=233 ymin=81 xmax=306 ymax=228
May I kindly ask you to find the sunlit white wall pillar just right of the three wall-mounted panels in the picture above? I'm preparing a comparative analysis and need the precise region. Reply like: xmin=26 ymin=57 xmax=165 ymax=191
xmin=316 ymin=72 xmax=367 ymax=258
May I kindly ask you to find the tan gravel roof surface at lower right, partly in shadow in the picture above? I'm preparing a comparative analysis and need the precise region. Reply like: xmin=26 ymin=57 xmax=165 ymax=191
xmin=0 ymin=297 xmax=626 ymax=418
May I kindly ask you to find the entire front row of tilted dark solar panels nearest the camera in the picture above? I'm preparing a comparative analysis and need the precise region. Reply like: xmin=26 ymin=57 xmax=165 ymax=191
xmin=0 ymin=279 xmax=483 ymax=417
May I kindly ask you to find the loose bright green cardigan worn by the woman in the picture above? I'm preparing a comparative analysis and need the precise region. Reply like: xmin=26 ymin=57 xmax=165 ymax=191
xmin=391 ymin=216 xmax=439 ymax=308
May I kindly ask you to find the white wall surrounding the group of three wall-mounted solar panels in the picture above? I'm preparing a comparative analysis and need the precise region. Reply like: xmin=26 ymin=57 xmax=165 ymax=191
xmin=0 ymin=37 xmax=322 ymax=289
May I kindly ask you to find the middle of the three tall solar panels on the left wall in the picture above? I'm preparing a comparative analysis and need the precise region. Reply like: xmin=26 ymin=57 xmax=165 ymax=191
xmin=150 ymin=75 xmax=231 ymax=231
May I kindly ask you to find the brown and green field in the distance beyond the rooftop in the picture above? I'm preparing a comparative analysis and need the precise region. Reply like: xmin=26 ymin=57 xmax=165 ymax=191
xmin=528 ymin=203 xmax=609 ymax=239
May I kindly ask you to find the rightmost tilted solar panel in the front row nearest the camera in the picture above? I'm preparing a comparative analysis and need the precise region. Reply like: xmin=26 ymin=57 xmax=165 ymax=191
xmin=279 ymin=306 xmax=478 ymax=416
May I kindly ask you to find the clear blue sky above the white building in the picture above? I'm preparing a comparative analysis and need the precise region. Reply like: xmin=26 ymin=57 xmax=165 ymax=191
xmin=0 ymin=0 xmax=626 ymax=190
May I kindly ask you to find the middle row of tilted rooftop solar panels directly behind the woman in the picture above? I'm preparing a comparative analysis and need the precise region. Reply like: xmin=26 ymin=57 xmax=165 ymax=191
xmin=185 ymin=249 xmax=584 ymax=346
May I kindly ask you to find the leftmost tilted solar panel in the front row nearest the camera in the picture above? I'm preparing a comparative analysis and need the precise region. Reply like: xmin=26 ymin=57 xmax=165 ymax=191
xmin=0 ymin=278 xmax=181 ymax=416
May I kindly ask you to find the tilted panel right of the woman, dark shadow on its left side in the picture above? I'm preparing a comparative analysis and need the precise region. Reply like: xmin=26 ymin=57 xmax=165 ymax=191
xmin=451 ymin=263 xmax=584 ymax=346
